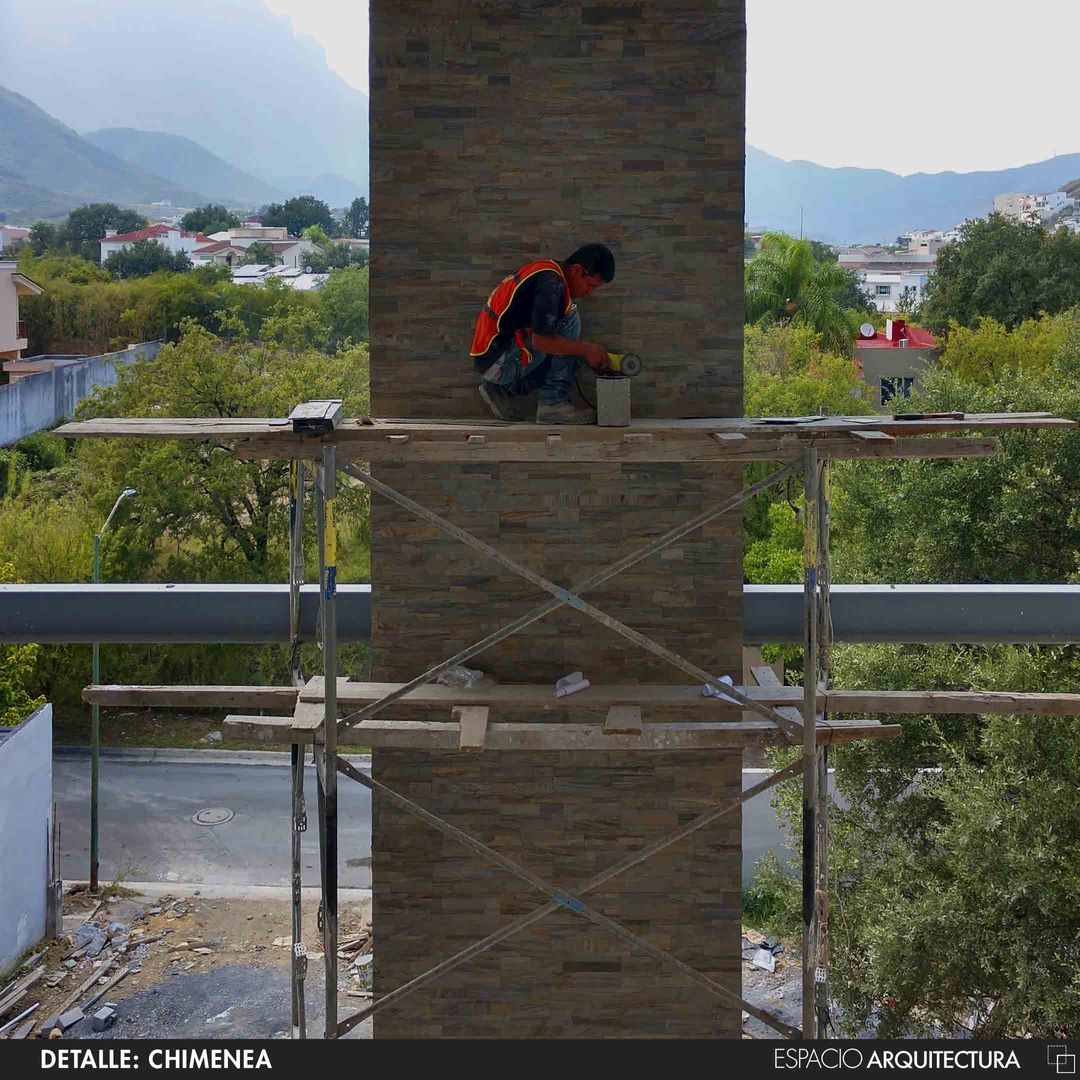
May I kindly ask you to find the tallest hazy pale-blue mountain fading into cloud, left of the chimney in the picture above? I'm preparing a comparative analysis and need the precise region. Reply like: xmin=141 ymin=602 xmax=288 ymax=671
xmin=0 ymin=0 xmax=367 ymax=194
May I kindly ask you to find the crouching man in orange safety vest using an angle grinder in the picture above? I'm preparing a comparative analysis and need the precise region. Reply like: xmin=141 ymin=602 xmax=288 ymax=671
xmin=471 ymin=244 xmax=615 ymax=423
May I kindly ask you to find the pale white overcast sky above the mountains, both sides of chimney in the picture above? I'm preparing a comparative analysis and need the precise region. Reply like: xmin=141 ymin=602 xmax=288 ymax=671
xmin=267 ymin=0 xmax=1080 ymax=173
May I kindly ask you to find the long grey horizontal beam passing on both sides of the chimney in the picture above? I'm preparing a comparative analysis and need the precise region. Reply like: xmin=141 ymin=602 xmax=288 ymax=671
xmin=0 ymin=584 xmax=1080 ymax=645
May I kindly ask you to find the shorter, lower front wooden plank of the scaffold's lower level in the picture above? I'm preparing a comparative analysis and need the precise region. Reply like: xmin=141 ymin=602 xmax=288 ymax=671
xmin=222 ymin=715 xmax=901 ymax=751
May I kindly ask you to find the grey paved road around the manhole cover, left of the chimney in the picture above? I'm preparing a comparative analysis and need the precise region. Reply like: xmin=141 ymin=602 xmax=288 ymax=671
xmin=53 ymin=754 xmax=372 ymax=889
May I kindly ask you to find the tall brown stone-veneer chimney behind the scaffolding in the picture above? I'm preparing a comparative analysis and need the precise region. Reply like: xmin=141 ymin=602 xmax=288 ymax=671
xmin=370 ymin=0 xmax=744 ymax=1037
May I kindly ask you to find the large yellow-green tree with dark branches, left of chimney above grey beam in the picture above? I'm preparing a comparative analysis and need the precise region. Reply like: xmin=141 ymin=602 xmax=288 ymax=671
xmin=76 ymin=316 xmax=367 ymax=581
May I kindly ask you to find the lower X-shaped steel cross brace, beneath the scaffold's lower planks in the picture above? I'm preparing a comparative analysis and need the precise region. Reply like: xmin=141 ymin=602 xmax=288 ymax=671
xmin=337 ymin=759 xmax=802 ymax=1038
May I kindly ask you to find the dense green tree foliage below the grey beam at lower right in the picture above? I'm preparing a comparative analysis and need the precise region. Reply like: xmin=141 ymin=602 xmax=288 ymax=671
xmin=765 ymin=646 xmax=1080 ymax=1038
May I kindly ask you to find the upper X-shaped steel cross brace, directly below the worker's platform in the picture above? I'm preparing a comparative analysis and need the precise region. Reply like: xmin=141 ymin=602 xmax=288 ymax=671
xmin=338 ymin=462 xmax=802 ymax=742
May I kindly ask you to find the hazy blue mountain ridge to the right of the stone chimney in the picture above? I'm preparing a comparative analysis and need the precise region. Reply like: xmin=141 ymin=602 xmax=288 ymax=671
xmin=746 ymin=146 xmax=1080 ymax=243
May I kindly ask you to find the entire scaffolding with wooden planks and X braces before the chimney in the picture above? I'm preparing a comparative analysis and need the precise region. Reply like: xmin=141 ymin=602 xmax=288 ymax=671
xmin=65 ymin=414 xmax=1080 ymax=1039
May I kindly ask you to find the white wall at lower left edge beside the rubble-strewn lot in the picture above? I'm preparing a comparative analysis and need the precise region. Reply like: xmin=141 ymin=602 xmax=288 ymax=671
xmin=0 ymin=705 xmax=53 ymax=977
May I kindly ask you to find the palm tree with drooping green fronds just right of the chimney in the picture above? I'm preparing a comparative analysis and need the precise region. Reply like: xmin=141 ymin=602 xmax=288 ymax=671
xmin=745 ymin=232 xmax=855 ymax=354
